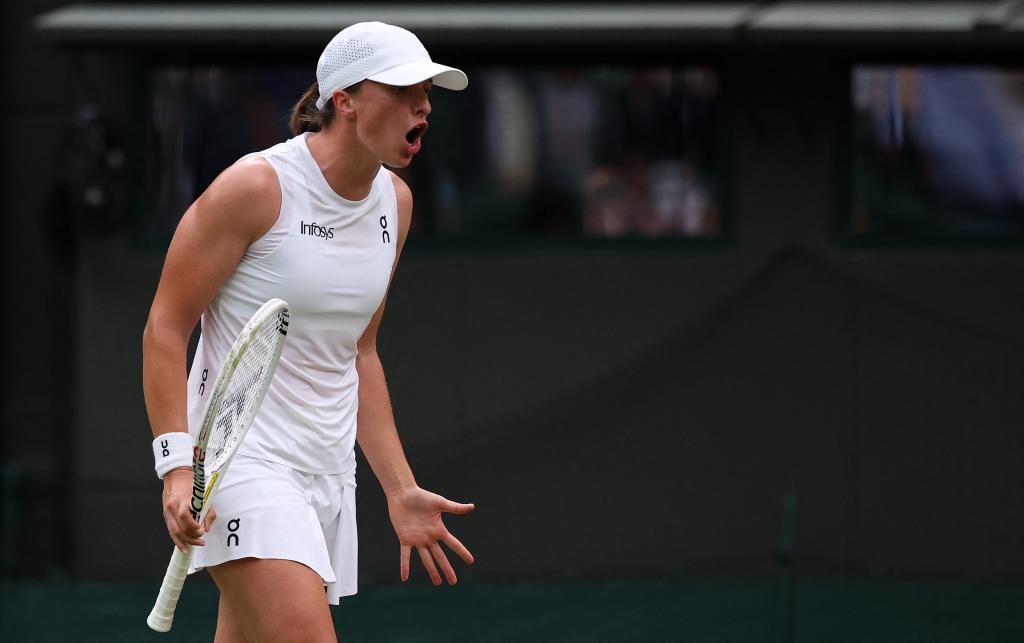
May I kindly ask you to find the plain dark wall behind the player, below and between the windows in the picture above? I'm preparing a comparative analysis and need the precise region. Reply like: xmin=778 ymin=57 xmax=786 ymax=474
xmin=3 ymin=3 xmax=1024 ymax=582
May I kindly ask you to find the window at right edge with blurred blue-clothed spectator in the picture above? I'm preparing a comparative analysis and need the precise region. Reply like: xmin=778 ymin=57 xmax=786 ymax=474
xmin=853 ymin=66 xmax=1024 ymax=241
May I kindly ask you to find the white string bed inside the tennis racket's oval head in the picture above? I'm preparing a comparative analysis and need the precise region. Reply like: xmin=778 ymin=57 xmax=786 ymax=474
xmin=206 ymin=316 xmax=283 ymax=471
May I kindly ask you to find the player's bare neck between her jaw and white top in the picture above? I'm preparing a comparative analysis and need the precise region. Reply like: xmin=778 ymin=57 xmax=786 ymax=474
xmin=306 ymin=127 xmax=381 ymax=201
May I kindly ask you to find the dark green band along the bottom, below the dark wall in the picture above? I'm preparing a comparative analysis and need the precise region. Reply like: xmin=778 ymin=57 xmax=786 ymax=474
xmin=0 ymin=578 xmax=1024 ymax=643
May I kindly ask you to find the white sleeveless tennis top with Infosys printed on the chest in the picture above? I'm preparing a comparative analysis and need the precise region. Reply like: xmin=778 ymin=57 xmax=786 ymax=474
xmin=188 ymin=134 xmax=398 ymax=473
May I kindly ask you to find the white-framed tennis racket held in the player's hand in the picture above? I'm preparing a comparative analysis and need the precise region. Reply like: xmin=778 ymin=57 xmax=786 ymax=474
xmin=145 ymin=299 xmax=289 ymax=632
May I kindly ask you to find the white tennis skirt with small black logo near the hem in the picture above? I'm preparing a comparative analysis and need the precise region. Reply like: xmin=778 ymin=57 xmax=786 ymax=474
xmin=188 ymin=455 xmax=358 ymax=605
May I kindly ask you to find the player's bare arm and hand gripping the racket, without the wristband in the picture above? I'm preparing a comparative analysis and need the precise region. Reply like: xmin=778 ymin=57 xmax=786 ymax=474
xmin=142 ymin=158 xmax=281 ymax=551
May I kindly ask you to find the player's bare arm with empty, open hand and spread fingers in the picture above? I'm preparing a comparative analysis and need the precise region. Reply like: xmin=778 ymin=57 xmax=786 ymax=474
xmin=355 ymin=175 xmax=473 ymax=585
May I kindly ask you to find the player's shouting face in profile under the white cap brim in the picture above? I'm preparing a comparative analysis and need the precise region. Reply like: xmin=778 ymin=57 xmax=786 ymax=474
xmin=352 ymin=80 xmax=432 ymax=168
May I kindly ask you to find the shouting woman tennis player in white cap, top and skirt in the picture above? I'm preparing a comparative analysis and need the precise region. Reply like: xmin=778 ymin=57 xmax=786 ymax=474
xmin=143 ymin=23 xmax=473 ymax=643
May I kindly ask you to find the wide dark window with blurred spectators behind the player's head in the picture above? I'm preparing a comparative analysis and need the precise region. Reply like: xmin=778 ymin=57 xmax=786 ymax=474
xmin=148 ymin=67 xmax=719 ymax=238
